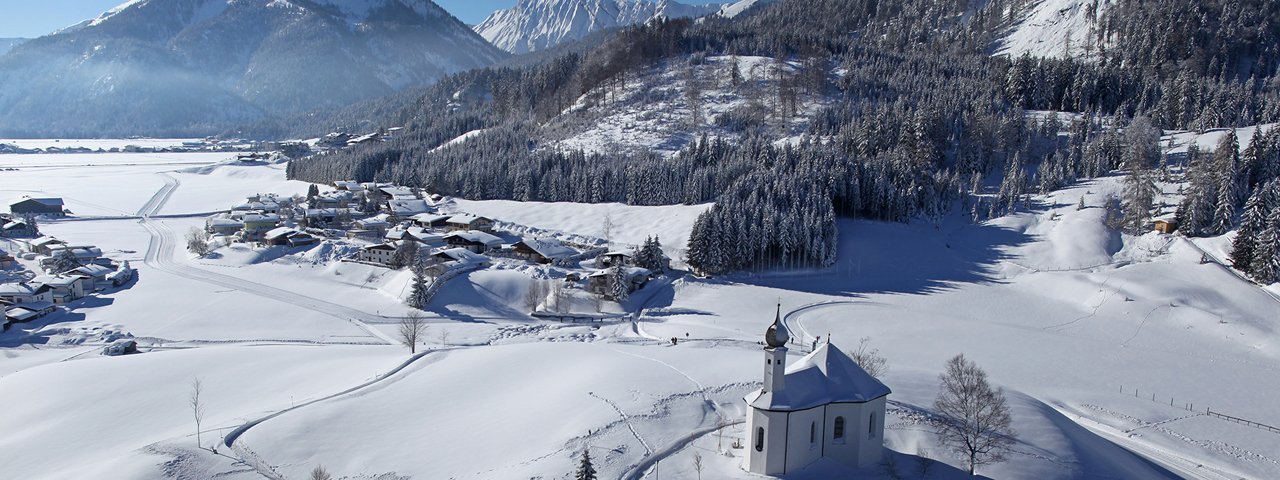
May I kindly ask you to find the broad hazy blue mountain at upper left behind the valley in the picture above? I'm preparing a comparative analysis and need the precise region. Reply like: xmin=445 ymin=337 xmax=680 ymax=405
xmin=0 ymin=0 xmax=506 ymax=136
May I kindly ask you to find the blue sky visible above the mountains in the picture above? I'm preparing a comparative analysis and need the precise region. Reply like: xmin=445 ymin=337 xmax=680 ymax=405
xmin=0 ymin=0 xmax=710 ymax=38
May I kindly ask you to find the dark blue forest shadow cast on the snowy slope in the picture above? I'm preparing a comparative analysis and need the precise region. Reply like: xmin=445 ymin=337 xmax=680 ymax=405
xmin=724 ymin=216 xmax=1032 ymax=296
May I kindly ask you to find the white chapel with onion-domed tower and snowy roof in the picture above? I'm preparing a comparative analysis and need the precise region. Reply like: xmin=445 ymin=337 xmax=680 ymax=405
xmin=745 ymin=307 xmax=890 ymax=475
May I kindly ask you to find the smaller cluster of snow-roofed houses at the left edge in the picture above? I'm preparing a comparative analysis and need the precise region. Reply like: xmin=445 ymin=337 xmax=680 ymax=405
xmin=0 ymin=197 xmax=133 ymax=349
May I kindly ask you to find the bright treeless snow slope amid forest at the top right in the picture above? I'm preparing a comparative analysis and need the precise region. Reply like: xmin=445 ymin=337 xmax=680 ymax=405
xmin=996 ymin=0 xmax=1111 ymax=58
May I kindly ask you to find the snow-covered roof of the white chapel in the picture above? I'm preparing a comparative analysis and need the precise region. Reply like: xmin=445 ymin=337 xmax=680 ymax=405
xmin=746 ymin=343 xmax=891 ymax=411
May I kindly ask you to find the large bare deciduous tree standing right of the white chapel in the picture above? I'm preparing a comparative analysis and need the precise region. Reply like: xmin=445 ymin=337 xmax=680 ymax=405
xmin=933 ymin=353 xmax=1015 ymax=475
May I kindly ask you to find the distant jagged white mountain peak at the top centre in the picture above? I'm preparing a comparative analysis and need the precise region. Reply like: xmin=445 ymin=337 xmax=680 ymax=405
xmin=475 ymin=0 xmax=719 ymax=54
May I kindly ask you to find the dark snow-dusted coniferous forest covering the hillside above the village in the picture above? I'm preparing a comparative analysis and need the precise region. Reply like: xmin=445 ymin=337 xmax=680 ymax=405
xmin=282 ymin=0 xmax=1280 ymax=276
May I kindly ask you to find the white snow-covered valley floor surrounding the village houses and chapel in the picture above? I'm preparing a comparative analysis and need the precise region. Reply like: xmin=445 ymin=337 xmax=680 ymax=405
xmin=0 ymin=147 xmax=1280 ymax=480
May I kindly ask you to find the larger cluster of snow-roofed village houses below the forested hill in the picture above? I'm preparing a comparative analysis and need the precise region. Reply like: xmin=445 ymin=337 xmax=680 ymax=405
xmin=199 ymin=180 xmax=671 ymax=320
